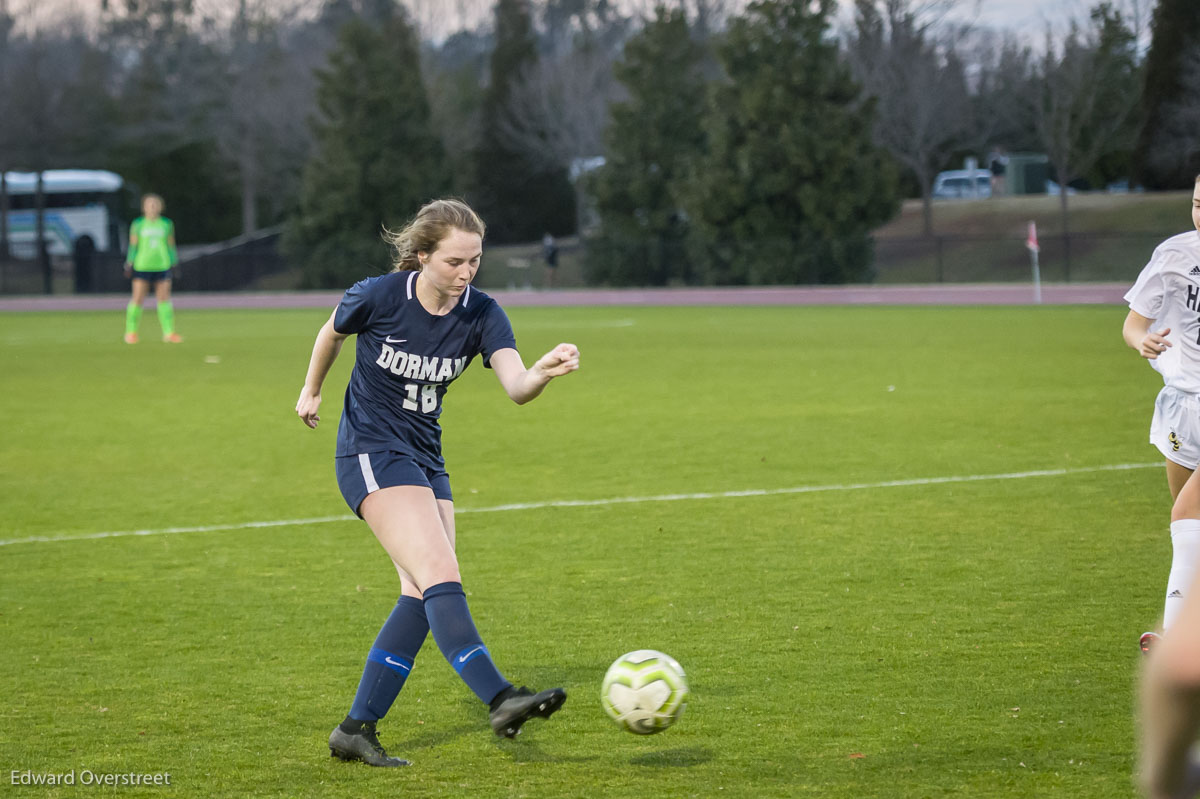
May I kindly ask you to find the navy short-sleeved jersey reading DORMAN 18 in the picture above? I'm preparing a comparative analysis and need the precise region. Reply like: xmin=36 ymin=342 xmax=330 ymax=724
xmin=334 ymin=272 xmax=516 ymax=468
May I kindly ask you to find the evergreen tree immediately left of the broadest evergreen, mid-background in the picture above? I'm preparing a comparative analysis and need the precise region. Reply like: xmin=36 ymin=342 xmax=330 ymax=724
xmin=586 ymin=6 xmax=706 ymax=286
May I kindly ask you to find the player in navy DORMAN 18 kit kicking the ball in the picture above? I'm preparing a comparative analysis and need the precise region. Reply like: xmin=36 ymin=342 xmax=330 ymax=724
xmin=296 ymin=195 xmax=580 ymax=767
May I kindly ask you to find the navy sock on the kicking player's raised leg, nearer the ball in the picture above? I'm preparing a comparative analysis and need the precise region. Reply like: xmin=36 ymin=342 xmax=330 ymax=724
xmin=424 ymin=583 xmax=512 ymax=703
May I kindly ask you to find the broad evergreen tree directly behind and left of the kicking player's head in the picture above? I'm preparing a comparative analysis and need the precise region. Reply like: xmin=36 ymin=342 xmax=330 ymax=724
xmin=284 ymin=7 xmax=450 ymax=287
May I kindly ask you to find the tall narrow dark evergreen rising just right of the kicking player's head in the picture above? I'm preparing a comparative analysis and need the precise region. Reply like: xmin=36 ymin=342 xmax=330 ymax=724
xmin=470 ymin=0 xmax=575 ymax=242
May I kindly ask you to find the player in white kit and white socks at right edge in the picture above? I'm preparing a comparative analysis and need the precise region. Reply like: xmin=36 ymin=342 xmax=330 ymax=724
xmin=1122 ymin=175 xmax=1200 ymax=653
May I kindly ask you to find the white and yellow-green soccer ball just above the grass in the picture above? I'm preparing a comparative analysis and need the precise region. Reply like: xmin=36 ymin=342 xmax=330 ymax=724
xmin=600 ymin=649 xmax=688 ymax=735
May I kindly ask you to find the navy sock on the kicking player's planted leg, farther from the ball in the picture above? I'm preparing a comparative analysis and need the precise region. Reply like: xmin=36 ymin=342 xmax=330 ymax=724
xmin=350 ymin=596 xmax=430 ymax=721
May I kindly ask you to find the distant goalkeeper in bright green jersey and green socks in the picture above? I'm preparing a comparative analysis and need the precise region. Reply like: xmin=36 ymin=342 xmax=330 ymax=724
xmin=125 ymin=194 xmax=184 ymax=344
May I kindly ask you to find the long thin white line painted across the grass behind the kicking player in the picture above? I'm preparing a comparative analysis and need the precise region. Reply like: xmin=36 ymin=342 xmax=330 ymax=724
xmin=0 ymin=461 xmax=1163 ymax=547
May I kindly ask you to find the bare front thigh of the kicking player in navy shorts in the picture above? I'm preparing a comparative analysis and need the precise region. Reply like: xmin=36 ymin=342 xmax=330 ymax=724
xmin=359 ymin=486 xmax=462 ymax=590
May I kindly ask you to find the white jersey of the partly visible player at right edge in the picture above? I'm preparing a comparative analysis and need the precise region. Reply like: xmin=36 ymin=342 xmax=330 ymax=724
xmin=1124 ymin=230 xmax=1200 ymax=394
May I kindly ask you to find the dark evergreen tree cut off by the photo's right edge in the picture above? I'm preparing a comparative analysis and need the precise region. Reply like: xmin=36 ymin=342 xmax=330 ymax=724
xmin=1134 ymin=0 xmax=1200 ymax=190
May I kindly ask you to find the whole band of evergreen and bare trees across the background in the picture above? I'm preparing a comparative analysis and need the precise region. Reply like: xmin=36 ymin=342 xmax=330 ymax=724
xmin=0 ymin=0 xmax=1200 ymax=287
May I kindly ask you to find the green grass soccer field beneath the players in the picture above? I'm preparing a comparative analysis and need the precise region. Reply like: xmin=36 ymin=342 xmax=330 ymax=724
xmin=0 ymin=300 xmax=1170 ymax=799
